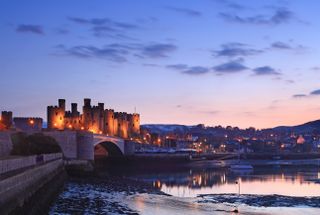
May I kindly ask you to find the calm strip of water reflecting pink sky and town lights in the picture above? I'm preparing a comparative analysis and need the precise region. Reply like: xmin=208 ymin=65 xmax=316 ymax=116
xmin=129 ymin=167 xmax=320 ymax=197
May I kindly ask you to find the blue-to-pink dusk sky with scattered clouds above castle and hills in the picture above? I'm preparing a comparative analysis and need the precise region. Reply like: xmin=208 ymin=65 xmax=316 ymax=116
xmin=0 ymin=0 xmax=320 ymax=128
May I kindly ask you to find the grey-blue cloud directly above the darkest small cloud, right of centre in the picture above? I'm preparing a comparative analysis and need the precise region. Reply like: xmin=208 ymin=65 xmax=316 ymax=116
xmin=213 ymin=43 xmax=263 ymax=57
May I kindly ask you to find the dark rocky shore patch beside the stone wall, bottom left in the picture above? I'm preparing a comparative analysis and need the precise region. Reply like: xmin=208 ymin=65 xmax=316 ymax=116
xmin=49 ymin=175 xmax=167 ymax=215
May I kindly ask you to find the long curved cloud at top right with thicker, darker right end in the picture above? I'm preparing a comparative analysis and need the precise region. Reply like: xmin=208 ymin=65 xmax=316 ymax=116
xmin=219 ymin=8 xmax=295 ymax=25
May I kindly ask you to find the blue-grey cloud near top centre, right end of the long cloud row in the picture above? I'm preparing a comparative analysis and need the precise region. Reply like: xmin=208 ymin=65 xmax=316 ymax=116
xmin=141 ymin=43 xmax=177 ymax=58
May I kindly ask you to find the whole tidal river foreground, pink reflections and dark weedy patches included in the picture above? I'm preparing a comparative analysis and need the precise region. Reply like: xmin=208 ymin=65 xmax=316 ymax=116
xmin=50 ymin=165 xmax=320 ymax=215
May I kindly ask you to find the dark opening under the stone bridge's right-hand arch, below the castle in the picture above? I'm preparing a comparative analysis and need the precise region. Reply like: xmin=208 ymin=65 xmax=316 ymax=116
xmin=94 ymin=140 xmax=123 ymax=157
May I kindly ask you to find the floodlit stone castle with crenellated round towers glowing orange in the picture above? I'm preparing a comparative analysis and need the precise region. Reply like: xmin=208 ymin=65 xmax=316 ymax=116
xmin=47 ymin=98 xmax=140 ymax=139
